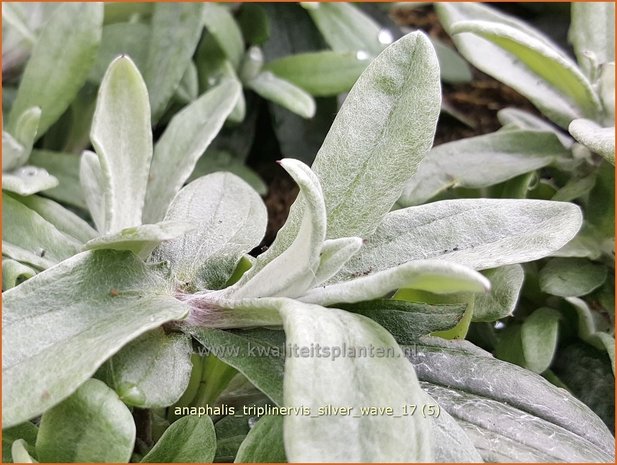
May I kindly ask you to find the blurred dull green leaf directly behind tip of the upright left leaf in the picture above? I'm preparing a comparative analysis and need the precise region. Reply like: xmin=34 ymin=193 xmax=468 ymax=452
xmin=88 ymin=21 xmax=150 ymax=83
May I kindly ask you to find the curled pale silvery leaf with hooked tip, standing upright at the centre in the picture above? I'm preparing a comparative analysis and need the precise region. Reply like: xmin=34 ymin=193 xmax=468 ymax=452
xmin=226 ymin=158 xmax=326 ymax=299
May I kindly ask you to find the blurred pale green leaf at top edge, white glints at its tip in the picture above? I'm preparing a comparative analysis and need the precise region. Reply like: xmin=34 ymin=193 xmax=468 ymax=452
xmin=302 ymin=3 xmax=384 ymax=56
